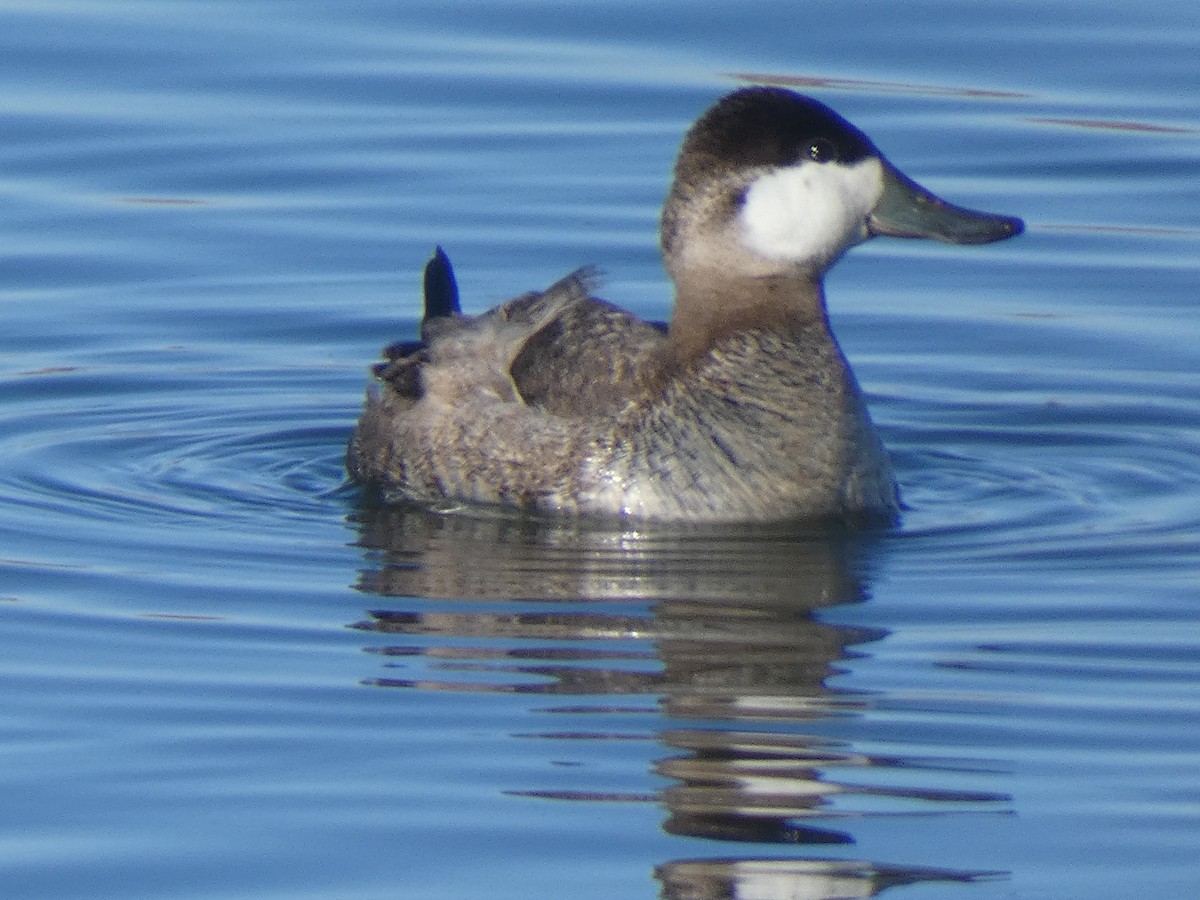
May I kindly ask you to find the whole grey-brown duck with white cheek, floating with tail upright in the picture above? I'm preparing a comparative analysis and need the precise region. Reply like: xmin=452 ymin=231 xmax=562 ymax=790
xmin=347 ymin=86 xmax=1024 ymax=524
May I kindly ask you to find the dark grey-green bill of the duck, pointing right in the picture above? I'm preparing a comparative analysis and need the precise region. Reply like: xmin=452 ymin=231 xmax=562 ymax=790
xmin=866 ymin=163 xmax=1025 ymax=244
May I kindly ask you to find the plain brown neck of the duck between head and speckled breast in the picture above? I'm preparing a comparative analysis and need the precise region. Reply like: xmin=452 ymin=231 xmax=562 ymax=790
xmin=667 ymin=270 xmax=828 ymax=365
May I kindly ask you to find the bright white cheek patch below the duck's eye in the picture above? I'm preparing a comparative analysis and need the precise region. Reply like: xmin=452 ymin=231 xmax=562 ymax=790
xmin=738 ymin=158 xmax=883 ymax=265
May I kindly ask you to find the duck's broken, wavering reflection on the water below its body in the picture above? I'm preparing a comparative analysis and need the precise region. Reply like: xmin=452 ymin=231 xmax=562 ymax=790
xmin=355 ymin=506 xmax=1008 ymax=900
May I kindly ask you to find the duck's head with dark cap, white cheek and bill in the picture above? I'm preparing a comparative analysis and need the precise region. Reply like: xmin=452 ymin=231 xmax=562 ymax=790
xmin=662 ymin=88 xmax=1024 ymax=286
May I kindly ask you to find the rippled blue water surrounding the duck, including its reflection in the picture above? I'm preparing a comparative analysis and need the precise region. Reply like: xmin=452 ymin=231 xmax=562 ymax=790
xmin=0 ymin=0 xmax=1200 ymax=900
